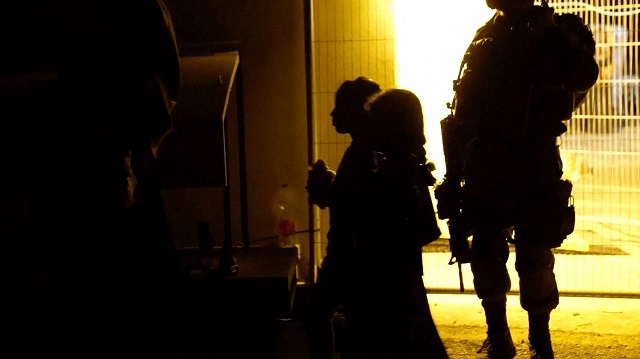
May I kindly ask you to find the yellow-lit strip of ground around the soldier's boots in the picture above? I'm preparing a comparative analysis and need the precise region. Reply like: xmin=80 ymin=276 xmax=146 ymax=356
xmin=429 ymin=293 xmax=640 ymax=359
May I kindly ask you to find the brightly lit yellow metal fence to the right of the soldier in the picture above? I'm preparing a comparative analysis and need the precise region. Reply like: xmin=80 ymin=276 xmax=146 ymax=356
xmin=549 ymin=0 xmax=640 ymax=296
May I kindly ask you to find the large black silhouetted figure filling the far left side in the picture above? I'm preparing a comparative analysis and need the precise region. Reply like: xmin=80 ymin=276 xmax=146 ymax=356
xmin=0 ymin=0 xmax=180 ymax=358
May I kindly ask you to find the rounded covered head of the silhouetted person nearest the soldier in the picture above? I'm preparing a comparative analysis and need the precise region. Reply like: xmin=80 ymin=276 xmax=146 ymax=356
xmin=367 ymin=89 xmax=427 ymax=158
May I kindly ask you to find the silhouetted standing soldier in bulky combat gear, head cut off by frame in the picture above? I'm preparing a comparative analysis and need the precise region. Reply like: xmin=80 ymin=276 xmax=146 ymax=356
xmin=436 ymin=0 xmax=598 ymax=359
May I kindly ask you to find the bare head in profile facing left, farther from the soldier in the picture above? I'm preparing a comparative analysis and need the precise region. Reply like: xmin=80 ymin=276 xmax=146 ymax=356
xmin=331 ymin=76 xmax=380 ymax=136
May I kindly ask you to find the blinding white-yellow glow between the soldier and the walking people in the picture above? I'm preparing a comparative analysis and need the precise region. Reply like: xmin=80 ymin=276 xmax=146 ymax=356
xmin=394 ymin=0 xmax=493 ymax=180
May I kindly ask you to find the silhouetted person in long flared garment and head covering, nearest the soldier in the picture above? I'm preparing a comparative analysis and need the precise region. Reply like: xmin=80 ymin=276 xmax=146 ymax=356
xmin=343 ymin=89 xmax=448 ymax=359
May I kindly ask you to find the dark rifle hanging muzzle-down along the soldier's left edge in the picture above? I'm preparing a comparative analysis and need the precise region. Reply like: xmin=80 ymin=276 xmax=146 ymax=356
xmin=434 ymin=60 xmax=471 ymax=292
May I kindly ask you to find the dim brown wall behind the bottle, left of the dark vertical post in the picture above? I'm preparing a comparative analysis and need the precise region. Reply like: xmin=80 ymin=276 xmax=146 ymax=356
xmin=161 ymin=0 xmax=309 ymax=244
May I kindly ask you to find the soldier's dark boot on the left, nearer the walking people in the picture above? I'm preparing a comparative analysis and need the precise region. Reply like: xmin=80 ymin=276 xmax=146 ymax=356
xmin=478 ymin=303 xmax=516 ymax=359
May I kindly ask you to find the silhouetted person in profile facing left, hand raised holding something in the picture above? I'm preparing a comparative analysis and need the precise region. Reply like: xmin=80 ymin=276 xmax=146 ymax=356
xmin=307 ymin=77 xmax=380 ymax=359
